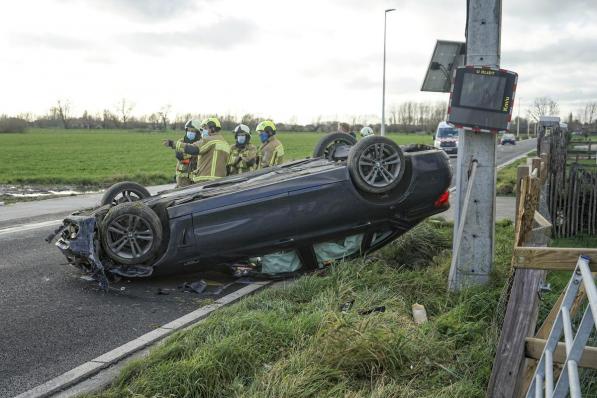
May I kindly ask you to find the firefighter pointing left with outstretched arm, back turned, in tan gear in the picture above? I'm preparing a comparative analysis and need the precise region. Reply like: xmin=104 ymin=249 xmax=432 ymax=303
xmin=167 ymin=117 xmax=230 ymax=183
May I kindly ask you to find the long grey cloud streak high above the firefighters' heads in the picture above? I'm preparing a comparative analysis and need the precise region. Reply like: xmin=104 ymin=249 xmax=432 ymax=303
xmin=119 ymin=18 xmax=258 ymax=53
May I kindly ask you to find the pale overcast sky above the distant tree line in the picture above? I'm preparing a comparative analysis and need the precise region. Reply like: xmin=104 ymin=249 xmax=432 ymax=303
xmin=0 ymin=0 xmax=597 ymax=123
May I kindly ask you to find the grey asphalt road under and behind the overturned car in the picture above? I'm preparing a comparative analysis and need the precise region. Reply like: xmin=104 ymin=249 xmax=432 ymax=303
xmin=0 ymin=140 xmax=535 ymax=397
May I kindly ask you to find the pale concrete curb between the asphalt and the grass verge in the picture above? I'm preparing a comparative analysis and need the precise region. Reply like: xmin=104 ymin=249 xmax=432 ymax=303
xmin=15 ymin=281 xmax=272 ymax=398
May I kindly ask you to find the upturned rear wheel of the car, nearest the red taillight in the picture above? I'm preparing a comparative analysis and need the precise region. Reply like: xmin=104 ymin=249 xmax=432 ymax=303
xmin=347 ymin=136 xmax=405 ymax=194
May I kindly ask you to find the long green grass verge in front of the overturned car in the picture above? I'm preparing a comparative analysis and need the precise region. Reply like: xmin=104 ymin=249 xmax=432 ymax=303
xmin=86 ymin=221 xmax=513 ymax=398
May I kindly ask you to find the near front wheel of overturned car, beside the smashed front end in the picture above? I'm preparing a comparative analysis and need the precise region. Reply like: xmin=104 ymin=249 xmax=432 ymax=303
xmin=100 ymin=202 xmax=162 ymax=265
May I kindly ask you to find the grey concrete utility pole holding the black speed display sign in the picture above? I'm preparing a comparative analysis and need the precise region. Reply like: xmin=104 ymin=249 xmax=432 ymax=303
xmin=449 ymin=0 xmax=502 ymax=290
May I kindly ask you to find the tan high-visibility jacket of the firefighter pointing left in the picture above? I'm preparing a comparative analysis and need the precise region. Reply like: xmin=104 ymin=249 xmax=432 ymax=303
xmin=175 ymin=134 xmax=230 ymax=182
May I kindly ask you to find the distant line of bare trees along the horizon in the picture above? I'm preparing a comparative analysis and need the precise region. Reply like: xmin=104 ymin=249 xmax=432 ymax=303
xmin=0 ymin=97 xmax=597 ymax=133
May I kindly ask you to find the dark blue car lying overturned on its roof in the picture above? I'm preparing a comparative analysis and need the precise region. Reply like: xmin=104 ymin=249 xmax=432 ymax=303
xmin=56 ymin=137 xmax=451 ymax=284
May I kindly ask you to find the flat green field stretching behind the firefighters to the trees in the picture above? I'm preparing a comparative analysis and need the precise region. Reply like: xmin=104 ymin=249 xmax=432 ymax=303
xmin=0 ymin=129 xmax=431 ymax=185
